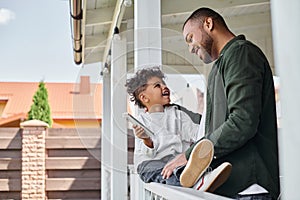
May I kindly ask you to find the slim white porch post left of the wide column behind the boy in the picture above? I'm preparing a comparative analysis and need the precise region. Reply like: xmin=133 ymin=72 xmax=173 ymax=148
xmin=111 ymin=34 xmax=128 ymax=200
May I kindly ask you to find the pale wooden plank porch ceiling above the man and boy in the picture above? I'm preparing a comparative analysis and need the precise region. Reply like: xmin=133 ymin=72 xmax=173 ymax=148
xmin=74 ymin=0 xmax=271 ymax=73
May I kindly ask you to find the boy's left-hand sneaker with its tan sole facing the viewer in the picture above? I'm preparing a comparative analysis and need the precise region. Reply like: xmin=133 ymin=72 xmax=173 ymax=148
xmin=180 ymin=139 xmax=214 ymax=187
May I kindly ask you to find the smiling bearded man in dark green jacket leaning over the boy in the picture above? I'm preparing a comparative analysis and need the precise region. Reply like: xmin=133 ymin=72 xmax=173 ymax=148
xmin=162 ymin=8 xmax=279 ymax=199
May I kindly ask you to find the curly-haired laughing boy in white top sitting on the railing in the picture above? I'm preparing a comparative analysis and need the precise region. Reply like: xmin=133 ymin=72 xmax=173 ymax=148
xmin=125 ymin=67 xmax=231 ymax=192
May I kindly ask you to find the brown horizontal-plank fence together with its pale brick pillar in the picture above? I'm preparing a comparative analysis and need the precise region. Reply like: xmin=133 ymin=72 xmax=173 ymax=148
xmin=0 ymin=121 xmax=134 ymax=200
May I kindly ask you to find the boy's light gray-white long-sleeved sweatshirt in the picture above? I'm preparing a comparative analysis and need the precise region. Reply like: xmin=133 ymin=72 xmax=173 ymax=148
xmin=134 ymin=106 xmax=199 ymax=170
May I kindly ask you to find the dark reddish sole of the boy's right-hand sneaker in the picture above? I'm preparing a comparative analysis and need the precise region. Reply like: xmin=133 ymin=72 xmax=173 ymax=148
xmin=204 ymin=162 xmax=232 ymax=192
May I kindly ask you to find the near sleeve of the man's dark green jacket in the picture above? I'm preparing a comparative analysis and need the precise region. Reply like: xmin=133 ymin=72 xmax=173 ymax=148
xmin=206 ymin=43 xmax=268 ymax=158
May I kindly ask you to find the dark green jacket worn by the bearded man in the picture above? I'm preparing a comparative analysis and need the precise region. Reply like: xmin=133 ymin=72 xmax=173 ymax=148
xmin=186 ymin=35 xmax=279 ymax=199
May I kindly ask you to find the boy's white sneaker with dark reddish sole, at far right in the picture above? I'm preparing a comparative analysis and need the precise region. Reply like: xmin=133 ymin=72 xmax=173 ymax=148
xmin=193 ymin=162 xmax=232 ymax=192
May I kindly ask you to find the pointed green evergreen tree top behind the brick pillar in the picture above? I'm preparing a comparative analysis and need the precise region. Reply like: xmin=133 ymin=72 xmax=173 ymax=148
xmin=28 ymin=81 xmax=52 ymax=127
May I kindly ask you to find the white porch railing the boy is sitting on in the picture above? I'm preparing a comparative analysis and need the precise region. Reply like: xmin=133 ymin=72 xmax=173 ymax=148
xmin=129 ymin=165 xmax=229 ymax=200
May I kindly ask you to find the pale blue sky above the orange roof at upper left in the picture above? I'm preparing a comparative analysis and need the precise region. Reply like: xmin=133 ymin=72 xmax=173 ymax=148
xmin=0 ymin=0 xmax=100 ymax=82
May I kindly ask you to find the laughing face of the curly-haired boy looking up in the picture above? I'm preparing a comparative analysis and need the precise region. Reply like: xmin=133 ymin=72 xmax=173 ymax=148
xmin=139 ymin=77 xmax=171 ymax=109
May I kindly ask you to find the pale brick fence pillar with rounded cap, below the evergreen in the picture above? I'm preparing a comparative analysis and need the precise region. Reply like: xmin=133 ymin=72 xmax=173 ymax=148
xmin=20 ymin=120 xmax=49 ymax=200
